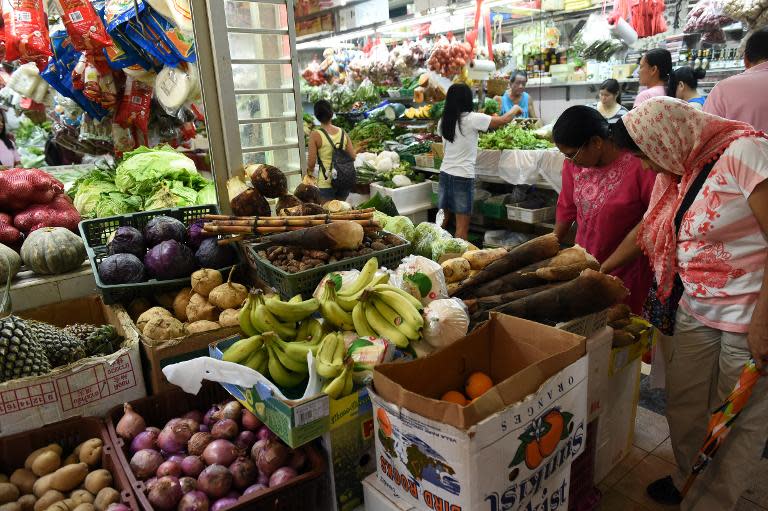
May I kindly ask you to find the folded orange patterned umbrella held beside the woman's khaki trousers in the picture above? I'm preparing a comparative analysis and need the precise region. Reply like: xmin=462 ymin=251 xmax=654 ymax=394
xmin=681 ymin=359 xmax=760 ymax=496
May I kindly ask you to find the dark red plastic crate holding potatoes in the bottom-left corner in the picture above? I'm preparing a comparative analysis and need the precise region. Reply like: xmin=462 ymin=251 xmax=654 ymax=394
xmin=0 ymin=417 xmax=139 ymax=510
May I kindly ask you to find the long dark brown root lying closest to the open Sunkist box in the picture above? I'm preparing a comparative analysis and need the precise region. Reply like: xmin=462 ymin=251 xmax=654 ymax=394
xmin=491 ymin=270 xmax=628 ymax=324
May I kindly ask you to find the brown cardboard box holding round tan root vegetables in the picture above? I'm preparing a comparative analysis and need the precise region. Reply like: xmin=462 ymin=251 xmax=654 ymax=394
xmin=117 ymin=308 xmax=240 ymax=395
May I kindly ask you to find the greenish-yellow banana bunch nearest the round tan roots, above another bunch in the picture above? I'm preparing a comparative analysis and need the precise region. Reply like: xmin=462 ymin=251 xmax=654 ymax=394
xmin=239 ymin=290 xmax=319 ymax=340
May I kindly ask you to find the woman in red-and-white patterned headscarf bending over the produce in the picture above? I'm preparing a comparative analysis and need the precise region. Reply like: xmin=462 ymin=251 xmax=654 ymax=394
xmin=603 ymin=98 xmax=768 ymax=511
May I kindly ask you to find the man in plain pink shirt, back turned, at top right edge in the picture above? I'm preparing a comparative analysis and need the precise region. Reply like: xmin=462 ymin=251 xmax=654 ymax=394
xmin=704 ymin=28 xmax=768 ymax=132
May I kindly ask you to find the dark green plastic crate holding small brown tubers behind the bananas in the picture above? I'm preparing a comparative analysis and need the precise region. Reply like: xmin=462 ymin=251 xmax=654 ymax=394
xmin=242 ymin=236 xmax=410 ymax=299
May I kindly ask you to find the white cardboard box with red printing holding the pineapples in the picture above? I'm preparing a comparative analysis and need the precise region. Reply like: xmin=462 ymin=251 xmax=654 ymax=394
xmin=0 ymin=296 xmax=147 ymax=436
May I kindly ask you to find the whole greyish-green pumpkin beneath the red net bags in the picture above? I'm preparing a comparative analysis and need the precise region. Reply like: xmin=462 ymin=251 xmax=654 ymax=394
xmin=21 ymin=227 xmax=86 ymax=275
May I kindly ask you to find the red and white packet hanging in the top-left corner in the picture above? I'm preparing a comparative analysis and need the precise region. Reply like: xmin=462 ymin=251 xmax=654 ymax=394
xmin=3 ymin=0 xmax=51 ymax=64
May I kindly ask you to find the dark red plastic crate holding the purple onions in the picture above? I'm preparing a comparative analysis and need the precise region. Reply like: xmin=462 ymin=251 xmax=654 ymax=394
xmin=106 ymin=382 xmax=328 ymax=511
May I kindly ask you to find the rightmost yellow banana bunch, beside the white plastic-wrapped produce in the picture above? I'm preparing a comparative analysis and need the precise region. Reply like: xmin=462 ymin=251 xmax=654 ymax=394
xmin=352 ymin=284 xmax=424 ymax=348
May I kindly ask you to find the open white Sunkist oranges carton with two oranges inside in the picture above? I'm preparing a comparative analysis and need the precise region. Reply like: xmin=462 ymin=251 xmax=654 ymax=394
xmin=371 ymin=314 xmax=587 ymax=511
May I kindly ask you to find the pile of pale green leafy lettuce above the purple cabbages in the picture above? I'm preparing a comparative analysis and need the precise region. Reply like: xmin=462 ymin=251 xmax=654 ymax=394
xmin=69 ymin=146 xmax=216 ymax=218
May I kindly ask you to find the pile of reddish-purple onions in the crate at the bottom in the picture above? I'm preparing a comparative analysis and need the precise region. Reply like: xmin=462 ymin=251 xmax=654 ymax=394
xmin=115 ymin=400 xmax=311 ymax=511
